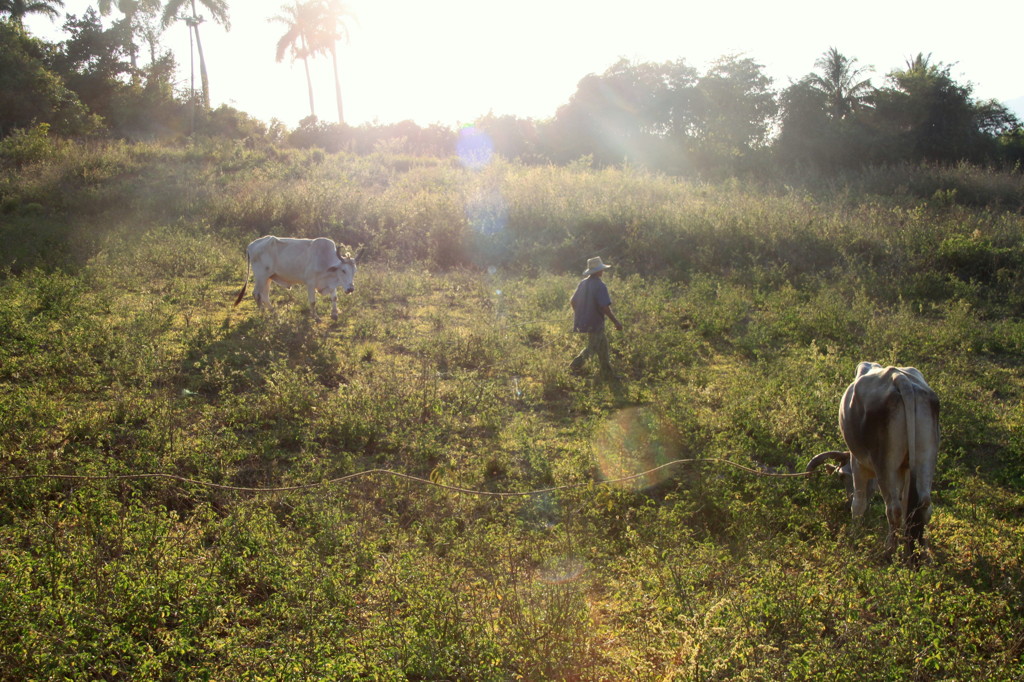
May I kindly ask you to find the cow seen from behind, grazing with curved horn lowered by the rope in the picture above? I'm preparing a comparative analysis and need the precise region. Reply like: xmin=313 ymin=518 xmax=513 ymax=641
xmin=807 ymin=363 xmax=939 ymax=552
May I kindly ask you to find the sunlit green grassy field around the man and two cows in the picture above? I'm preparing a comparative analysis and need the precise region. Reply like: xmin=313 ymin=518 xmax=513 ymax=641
xmin=0 ymin=140 xmax=1024 ymax=680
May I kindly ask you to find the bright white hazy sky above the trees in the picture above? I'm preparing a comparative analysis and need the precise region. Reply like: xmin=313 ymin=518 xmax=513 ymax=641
xmin=28 ymin=0 xmax=1024 ymax=127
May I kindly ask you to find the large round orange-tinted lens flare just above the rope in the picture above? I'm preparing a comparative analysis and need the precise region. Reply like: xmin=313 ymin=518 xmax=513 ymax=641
xmin=593 ymin=408 xmax=680 ymax=491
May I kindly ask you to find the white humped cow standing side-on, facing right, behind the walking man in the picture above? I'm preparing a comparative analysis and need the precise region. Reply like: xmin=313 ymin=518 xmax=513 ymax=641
xmin=234 ymin=237 xmax=355 ymax=319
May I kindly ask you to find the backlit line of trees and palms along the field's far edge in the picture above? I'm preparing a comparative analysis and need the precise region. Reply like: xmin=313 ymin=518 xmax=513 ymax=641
xmin=0 ymin=0 xmax=1024 ymax=174
